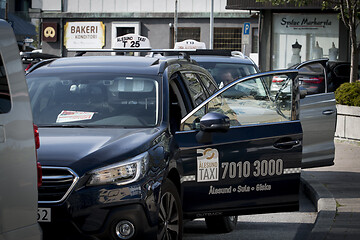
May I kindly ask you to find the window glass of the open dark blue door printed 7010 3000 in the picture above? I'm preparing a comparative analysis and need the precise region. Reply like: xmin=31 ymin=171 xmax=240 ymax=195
xmin=180 ymin=76 xmax=293 ymax=131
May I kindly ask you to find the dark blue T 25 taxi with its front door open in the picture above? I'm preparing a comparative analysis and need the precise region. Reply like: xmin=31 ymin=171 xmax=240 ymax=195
xmin=27 ymin=51 xmax=302 ymax=240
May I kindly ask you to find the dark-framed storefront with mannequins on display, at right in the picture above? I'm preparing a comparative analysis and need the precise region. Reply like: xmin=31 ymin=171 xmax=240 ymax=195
xmin=226 ymin=0 xmax=350 ymax=71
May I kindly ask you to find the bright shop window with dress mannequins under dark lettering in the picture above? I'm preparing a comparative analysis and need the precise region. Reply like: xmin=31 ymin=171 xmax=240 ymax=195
xmin=272 ymin=13 xmax=339 ymax=69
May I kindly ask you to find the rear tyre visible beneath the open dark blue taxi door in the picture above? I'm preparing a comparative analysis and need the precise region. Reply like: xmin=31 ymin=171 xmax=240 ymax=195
xmin=205 ymin=216 xmax=237 ymax=233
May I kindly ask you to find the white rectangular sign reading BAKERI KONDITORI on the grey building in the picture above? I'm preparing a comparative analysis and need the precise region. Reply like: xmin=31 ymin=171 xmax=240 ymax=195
xmin=64 ymin=22 xmax=105 ymax=49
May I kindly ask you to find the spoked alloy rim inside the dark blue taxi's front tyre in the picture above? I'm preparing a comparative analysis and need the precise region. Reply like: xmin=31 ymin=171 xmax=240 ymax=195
xmin=158 ymin=192 xmax=180 ymax=240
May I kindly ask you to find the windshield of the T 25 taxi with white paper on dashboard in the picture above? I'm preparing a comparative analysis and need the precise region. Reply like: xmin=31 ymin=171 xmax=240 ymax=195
xmin=27 ymin=72 xmax=160 ymax=127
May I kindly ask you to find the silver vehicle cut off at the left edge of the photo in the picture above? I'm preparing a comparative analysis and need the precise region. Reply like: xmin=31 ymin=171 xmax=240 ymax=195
xmin=0 ymin=20 xmax=42 ymax=240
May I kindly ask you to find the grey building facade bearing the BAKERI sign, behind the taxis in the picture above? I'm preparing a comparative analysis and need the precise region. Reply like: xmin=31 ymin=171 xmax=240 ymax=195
xmin=30 ymin=0 xmax=258 ymax=57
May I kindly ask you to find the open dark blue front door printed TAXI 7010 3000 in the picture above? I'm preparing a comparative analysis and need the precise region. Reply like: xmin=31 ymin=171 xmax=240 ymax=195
xmin=175 ymin=70 xmax=302 ymax=218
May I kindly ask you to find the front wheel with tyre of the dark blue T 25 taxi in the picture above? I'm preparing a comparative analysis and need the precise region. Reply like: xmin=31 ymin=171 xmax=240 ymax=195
xmin=157 ymin=179 xmax=183 ymax=240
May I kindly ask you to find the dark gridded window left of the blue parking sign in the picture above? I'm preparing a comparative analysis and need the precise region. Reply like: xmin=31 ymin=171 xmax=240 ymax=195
xmin=214 ymin=28 xmax=242 ymax=51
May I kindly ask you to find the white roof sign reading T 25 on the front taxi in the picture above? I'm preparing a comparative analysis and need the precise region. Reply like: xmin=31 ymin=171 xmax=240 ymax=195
xmin=113 ymin=34 xmax=151 ymax=49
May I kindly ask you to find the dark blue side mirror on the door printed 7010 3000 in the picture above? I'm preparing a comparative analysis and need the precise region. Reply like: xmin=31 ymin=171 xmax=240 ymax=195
xmin=196 ymin=112 xmax=230 ymax=143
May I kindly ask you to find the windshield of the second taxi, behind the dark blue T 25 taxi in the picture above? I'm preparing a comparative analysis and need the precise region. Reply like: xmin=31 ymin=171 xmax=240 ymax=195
xmin=197 ymin=60 xmax=257 ymax=88
